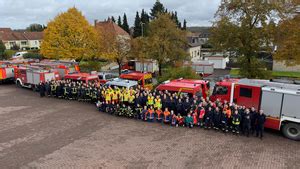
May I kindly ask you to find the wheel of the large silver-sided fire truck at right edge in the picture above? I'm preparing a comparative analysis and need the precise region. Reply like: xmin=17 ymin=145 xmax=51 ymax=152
xmin=283 ymin=123 xmax=300 ymax=141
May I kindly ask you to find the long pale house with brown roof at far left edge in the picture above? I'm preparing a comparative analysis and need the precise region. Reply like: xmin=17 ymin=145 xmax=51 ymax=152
xmin=0 ymin=28 xmax=43 ymax=50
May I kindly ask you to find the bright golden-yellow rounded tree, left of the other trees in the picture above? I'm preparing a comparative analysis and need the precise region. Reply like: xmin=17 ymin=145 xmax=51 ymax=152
xmin=41 ymin=8 xmax=100 ymax=60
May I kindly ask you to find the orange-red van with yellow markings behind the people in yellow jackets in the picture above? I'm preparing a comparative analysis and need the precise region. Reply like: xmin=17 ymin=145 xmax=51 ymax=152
xmin=120 ymin=72 xmax=153 ymax=90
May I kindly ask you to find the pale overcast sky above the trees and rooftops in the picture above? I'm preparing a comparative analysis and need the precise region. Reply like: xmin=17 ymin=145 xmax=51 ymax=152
xmin=0 ymin=0 xmax=220 ymax=29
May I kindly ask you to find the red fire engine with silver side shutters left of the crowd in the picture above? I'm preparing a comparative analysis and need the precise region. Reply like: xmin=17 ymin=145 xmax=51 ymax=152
xmin=14 ymin=66 xmax=60 ymax=89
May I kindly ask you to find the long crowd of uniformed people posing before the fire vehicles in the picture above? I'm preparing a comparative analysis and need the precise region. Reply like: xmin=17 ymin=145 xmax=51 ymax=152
xmin=40 ymin=80 xmax=266 ymax=139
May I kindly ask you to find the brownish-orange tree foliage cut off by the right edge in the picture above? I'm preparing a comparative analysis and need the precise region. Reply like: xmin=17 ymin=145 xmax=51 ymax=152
xmin=274 ymin=9 xmax=300 ymax=66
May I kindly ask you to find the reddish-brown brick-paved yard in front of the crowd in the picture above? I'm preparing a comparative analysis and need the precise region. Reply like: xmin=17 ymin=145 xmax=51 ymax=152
xmin=0 ymin=85 xmax=300 ymax=169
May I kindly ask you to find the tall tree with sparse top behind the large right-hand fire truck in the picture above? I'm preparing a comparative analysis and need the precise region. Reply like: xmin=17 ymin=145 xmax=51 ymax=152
xmin=210 ymin=0 xmax=296 ymax=78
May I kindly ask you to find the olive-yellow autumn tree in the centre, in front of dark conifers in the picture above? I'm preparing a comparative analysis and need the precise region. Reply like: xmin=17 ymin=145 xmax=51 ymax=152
xmin=140 ymin=14 xmax=188 ymax=75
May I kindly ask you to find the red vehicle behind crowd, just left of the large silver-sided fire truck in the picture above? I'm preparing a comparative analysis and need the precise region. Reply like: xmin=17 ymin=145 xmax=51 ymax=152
xmin=156 ymin=79 xmax=207 ymax=97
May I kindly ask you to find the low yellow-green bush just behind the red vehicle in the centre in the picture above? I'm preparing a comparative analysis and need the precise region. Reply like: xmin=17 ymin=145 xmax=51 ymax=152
xmin=157 ymin=67 xmax=200 ymax=83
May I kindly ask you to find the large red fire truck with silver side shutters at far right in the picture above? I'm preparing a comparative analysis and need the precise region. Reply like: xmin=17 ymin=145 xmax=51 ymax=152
xmin=211 ymin=79 xmax=300 ymax=140
